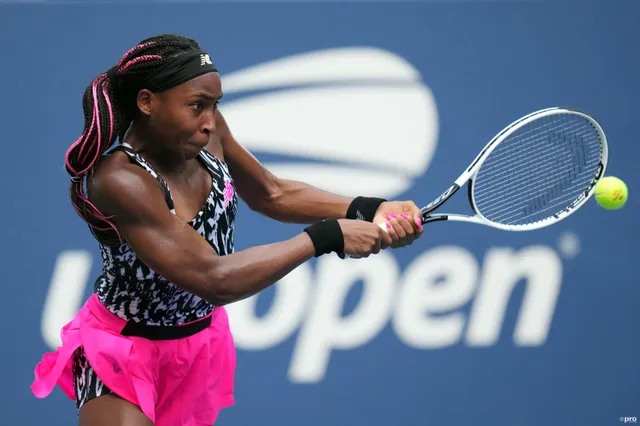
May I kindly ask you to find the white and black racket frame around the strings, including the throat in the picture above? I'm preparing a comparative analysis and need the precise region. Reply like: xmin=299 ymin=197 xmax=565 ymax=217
xmin=421 ymin=107 xmax=609 ymax=231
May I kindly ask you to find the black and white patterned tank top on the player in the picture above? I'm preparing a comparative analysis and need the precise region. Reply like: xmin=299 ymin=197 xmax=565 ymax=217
xmin=94 ymin=144 xmax=238 ymax=326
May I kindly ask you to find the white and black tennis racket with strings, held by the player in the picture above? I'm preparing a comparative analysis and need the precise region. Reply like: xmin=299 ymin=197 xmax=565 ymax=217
xmin=404 ymin=108 xmax=608 ymax=231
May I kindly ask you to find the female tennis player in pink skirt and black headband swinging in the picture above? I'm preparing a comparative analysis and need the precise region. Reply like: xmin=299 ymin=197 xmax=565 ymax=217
xmin=31 ymin=35 xmax=423 ymax=426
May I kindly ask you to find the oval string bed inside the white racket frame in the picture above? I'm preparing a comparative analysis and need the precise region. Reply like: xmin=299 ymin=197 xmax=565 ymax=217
xmin=473 ymin=113 xmax=601 ymax=225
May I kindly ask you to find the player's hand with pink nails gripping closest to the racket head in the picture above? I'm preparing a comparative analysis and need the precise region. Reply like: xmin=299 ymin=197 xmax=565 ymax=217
xmin=373 ymin=201 xmax=424 ymax=248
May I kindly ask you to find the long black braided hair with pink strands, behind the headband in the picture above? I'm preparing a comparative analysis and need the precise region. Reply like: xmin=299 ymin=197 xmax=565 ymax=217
xmin=65 ymin=34 xmax=200 ymax=244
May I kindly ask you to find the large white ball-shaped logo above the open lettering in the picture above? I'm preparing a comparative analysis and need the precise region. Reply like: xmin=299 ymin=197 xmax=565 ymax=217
xmin=221 ymin=47 xmax=438 ymax=197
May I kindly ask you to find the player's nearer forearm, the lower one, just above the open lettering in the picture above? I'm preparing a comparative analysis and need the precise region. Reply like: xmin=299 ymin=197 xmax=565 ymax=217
xmin=204 ymin=232 xmax=315 ymax=305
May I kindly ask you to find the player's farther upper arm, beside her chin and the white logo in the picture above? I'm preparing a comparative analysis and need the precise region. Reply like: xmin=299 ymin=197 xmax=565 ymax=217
xmin=216 ymin=110 xmax=279 ymax=211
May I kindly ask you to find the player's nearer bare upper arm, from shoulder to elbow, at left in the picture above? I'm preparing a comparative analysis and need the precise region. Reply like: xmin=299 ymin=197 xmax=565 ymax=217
xmin=89 ymin=158 xmax=218 ymax=299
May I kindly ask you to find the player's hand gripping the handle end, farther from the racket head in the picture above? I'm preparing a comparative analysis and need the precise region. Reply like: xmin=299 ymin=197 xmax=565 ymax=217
xmin=338 ymin=219 xmax=392 ymax=259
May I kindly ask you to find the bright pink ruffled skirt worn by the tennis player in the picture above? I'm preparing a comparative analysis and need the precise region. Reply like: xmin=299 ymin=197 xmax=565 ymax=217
xmin=31 ymin=295 xmax=236 ymax=426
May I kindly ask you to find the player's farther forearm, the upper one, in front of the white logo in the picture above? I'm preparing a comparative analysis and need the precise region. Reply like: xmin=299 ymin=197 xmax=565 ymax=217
xmin=260 ymin=179 xmax=353 ymax=223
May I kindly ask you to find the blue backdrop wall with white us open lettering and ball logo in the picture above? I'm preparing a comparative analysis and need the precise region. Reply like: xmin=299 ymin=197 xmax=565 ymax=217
xmin=0 ymin=1 xmax=640 ymax=426
